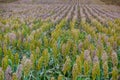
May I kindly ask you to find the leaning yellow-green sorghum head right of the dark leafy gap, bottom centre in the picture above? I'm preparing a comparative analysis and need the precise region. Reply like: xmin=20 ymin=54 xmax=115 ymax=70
xmin=62 ymin=56 xmax=71 ymax=75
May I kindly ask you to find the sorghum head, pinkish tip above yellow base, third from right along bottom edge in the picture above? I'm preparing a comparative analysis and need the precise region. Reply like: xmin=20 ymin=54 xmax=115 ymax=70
xmin=92 ymin=56 xmax=100 ymax=80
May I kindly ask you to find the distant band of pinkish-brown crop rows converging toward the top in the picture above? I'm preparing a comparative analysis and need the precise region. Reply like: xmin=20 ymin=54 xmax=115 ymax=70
xmin=0 ymin=4 xmax=120 ymax=23
